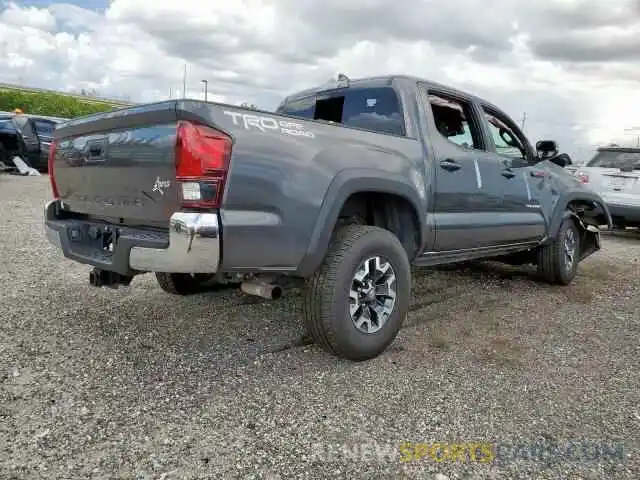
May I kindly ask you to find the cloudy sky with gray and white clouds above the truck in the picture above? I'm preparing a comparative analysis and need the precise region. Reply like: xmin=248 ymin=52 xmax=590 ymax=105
xmin=0 ymin=0 xmax=640 ymax=160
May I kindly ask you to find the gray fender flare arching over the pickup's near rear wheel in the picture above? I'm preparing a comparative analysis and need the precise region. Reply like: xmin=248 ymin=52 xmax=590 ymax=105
xmin=297 ymin=169 xmax=427 ymax=277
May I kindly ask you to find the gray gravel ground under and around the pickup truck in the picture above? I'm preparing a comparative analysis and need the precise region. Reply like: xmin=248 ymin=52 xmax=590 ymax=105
xmin=0 ymin=175 xmax=640 ymax=479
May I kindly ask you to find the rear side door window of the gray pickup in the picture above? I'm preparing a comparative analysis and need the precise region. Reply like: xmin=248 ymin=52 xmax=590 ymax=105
xmin=428 ymin=92 xmax=484 ymax=150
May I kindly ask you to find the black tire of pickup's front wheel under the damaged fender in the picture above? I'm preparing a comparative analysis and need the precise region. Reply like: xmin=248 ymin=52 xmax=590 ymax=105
xmin=538 ymin=214 xmax=581 ymax=285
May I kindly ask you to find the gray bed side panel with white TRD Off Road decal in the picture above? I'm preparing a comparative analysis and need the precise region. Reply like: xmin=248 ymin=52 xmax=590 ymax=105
xmin=184 ymin=100 xmax=426 ymax=271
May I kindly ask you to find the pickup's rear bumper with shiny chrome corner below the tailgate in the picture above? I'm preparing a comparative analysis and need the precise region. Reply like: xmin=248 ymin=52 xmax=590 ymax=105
xmin=44 ymin=200 xmax=220 ymax=275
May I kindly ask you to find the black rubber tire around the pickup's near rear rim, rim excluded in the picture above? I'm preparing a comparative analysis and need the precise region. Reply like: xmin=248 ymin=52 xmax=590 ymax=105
xmin=303 ymin=225 xmax=411 ymax=361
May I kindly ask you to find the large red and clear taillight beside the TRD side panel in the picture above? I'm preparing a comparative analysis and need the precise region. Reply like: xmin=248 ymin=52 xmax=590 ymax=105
xmin=176 ymin=121 xmax=232 ymax=208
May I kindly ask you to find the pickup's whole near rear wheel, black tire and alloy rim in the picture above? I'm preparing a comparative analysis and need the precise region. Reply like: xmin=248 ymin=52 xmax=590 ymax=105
xmin=304 ymin=225 xmax=411 ymax=361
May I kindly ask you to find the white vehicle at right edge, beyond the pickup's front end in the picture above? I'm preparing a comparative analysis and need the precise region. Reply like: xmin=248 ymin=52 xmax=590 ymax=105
xmin=574 ymin=147 xmax=640 ymax=228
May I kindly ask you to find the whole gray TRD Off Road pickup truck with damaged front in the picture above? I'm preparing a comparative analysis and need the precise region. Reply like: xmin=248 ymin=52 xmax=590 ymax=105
xmin=45 ymin=76 xmax=611 ymax=361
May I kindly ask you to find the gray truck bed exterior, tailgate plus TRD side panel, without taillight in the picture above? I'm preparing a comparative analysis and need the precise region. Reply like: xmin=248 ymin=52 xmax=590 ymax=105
xmin=47 ymin=95 xmax=424 ymax=271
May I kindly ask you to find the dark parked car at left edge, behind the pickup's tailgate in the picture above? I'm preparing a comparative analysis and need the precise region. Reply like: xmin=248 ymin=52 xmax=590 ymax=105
xmin=0 ymin=112 xmax=65 ymax=172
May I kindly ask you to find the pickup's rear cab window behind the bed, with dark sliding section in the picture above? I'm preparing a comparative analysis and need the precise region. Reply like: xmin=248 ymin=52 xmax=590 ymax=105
xmin=277 ymin=87 xmax=406 ymax=136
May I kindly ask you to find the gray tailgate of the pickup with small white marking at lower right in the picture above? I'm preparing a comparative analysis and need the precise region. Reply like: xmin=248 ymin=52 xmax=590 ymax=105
xmin=52 ymin=101 xmax=179 ymax=226
